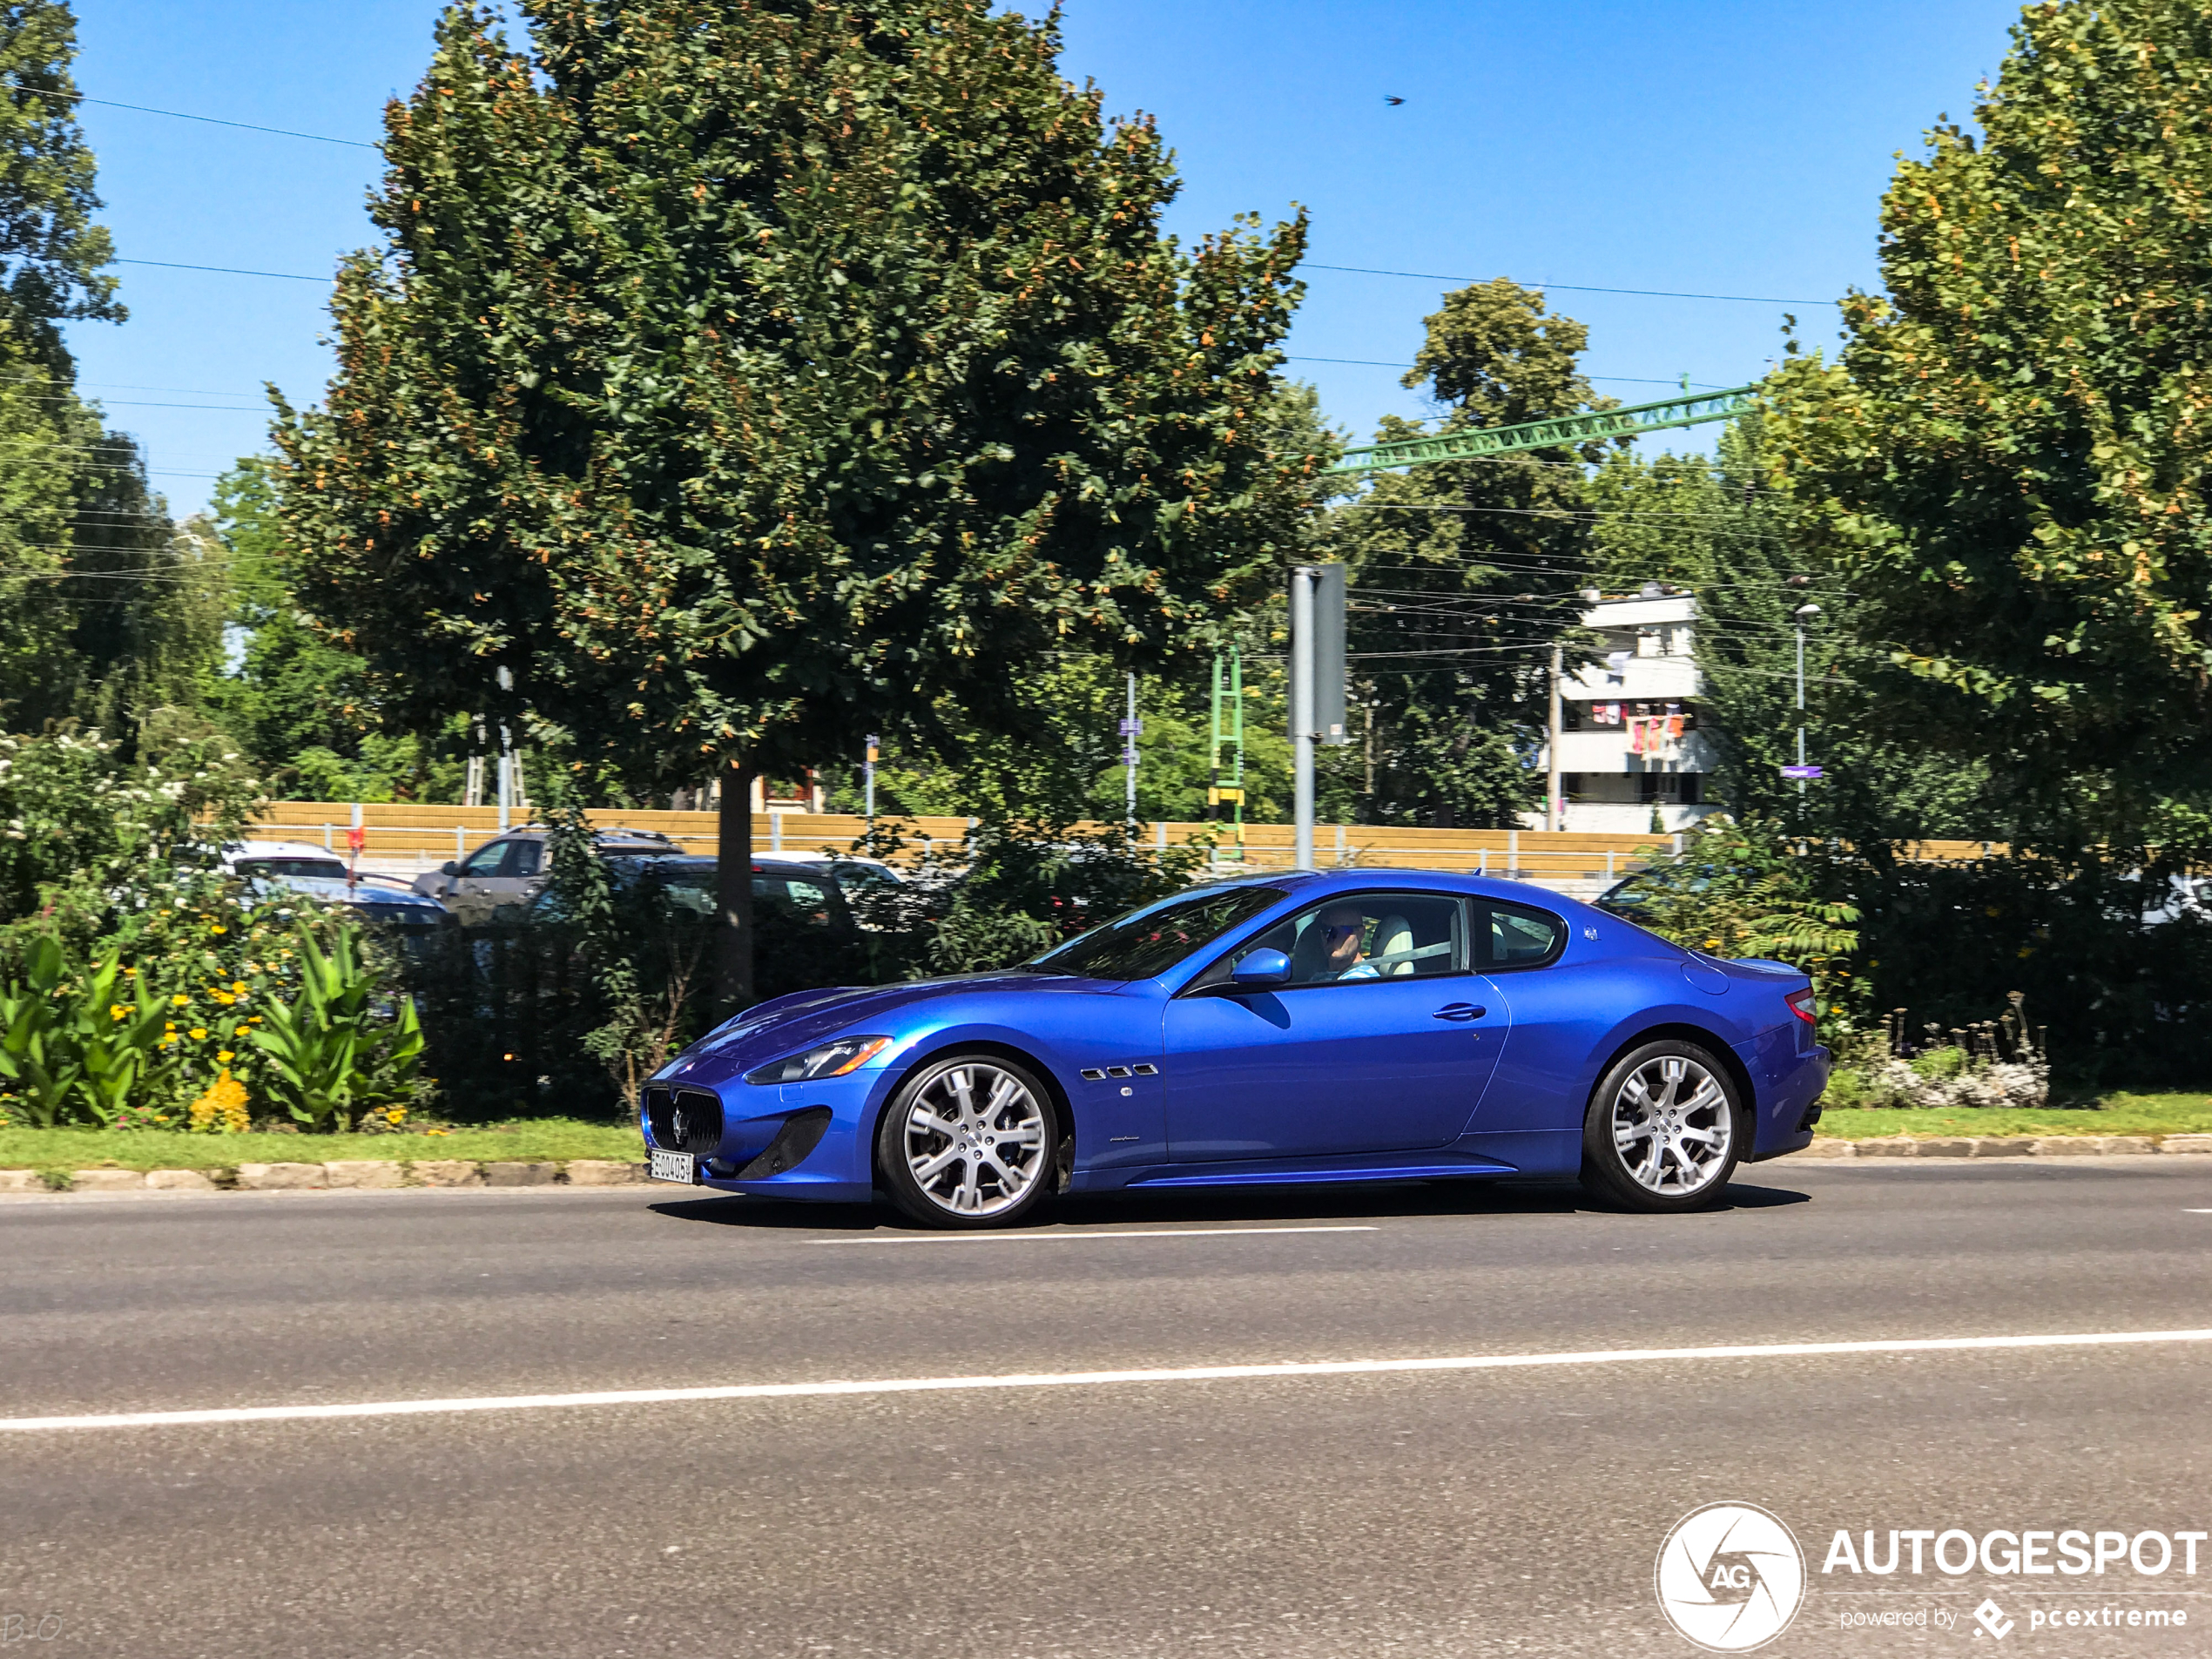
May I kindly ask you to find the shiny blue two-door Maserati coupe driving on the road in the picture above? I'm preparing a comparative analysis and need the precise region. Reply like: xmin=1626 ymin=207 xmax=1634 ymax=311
xmin=639 ymin=869 xmax=1830 ymax=1228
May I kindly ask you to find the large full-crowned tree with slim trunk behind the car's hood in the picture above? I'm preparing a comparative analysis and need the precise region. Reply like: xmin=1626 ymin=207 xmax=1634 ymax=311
xmin=279 ymin=0 xmax=1303 ymax=1002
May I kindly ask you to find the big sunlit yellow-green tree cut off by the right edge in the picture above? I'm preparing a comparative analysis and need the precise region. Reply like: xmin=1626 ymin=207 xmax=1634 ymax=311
xmin=1767 ymin=0 xmax=2212 ymax=856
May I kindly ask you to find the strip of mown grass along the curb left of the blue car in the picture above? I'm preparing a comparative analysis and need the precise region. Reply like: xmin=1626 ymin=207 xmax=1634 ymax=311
xmin=0 ymin=1117 xmax=646 ymax=1170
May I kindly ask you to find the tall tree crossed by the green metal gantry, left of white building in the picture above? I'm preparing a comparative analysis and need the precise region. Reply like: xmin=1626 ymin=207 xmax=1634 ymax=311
xmin=1330 ymin=277 xmax=1606 ymax=827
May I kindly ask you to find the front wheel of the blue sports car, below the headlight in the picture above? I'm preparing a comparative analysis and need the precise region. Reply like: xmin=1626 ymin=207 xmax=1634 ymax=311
xmin=876 ymin=1055 xmax=1060 ymax=1228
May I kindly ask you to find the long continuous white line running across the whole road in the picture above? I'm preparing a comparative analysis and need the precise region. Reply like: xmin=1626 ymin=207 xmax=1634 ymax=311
xmin=0 ymin=1330 xmax=2212 ymax=1433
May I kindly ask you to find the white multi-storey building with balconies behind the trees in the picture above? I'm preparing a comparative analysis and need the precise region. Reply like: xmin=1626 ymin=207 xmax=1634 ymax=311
xmin=1531 ymin=582 xmax=1716 ymax=834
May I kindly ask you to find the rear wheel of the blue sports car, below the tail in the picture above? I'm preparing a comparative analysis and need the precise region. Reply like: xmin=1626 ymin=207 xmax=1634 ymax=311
xmin=1581 ymin=1040 xmax=1745 ymax=1214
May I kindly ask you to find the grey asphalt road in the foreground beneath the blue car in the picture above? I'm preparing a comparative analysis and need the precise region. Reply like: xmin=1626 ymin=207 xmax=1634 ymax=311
xmin=0 ymin=1159 xmax=2212 ymax=1659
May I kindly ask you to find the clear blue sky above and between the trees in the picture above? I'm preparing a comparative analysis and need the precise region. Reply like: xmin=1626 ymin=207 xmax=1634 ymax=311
xmin=71 ymin=0 xmax=2017 ymax=511
